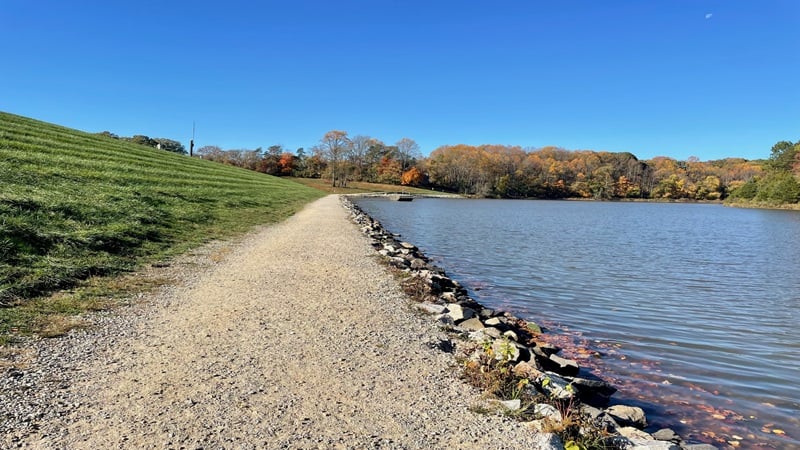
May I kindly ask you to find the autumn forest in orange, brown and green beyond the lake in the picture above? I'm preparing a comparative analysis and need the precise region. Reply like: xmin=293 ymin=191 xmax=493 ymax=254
xmin=111 ymin=130 xmax=800 ymax=205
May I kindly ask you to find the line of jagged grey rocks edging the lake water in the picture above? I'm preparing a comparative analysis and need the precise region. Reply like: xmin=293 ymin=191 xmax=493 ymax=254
xmin=341 ymin=196 xmax=717 ymax=450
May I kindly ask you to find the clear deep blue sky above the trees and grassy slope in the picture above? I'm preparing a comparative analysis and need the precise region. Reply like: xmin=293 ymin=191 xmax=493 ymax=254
xmin=0 ymin=0 xmax=800 ymax=160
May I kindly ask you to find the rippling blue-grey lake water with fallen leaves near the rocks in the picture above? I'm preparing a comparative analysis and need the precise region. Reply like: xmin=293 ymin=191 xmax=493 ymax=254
xmin=357 ymin=199 xmax=800 ymax=449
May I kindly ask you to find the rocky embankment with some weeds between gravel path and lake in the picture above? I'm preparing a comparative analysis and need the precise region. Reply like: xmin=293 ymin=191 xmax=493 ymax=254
xmin=342 ymin=197 xmax=716 ymax=450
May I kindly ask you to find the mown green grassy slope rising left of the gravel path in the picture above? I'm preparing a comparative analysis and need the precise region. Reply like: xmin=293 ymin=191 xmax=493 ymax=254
xmin=0 ymin=112 xmax=324 ymax=340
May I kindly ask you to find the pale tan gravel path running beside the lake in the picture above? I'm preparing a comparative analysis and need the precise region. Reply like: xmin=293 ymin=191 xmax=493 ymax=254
xmin=0 ymin=196 xmax=548 ymax=449
